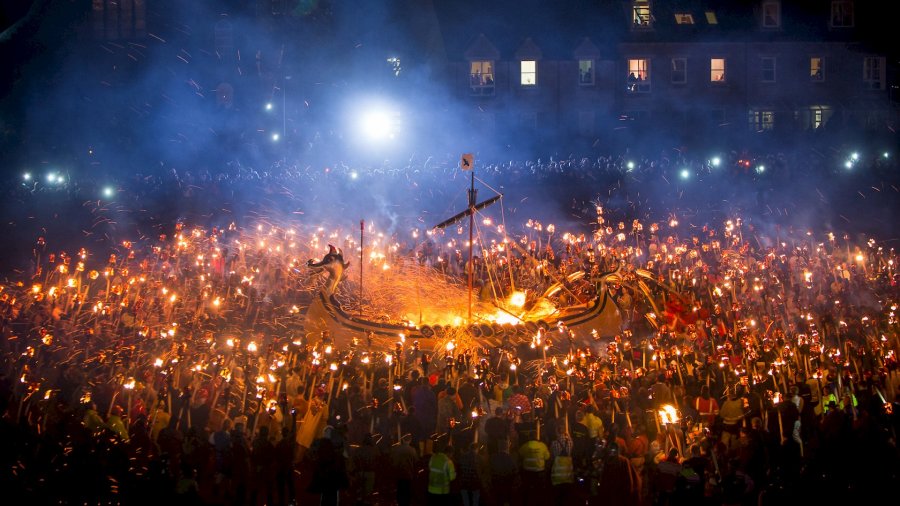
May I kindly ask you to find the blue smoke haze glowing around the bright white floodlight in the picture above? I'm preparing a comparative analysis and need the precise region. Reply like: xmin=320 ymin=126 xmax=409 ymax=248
xmin=0 ymin=0 xmax=897 ymax=272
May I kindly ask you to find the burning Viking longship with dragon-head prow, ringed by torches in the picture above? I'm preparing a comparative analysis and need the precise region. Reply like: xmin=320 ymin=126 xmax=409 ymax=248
xmin=304 ymin=164 xmax=622 ymax=349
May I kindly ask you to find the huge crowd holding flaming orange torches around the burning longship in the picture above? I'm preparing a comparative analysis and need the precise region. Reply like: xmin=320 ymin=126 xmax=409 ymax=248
xmin=0 ymin=147 xmax=900 ymax=506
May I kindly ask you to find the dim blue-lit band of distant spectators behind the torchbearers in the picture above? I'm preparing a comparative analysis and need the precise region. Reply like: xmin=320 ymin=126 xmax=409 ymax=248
xmin=3 ymin=142 xmax=896 ymax=223
